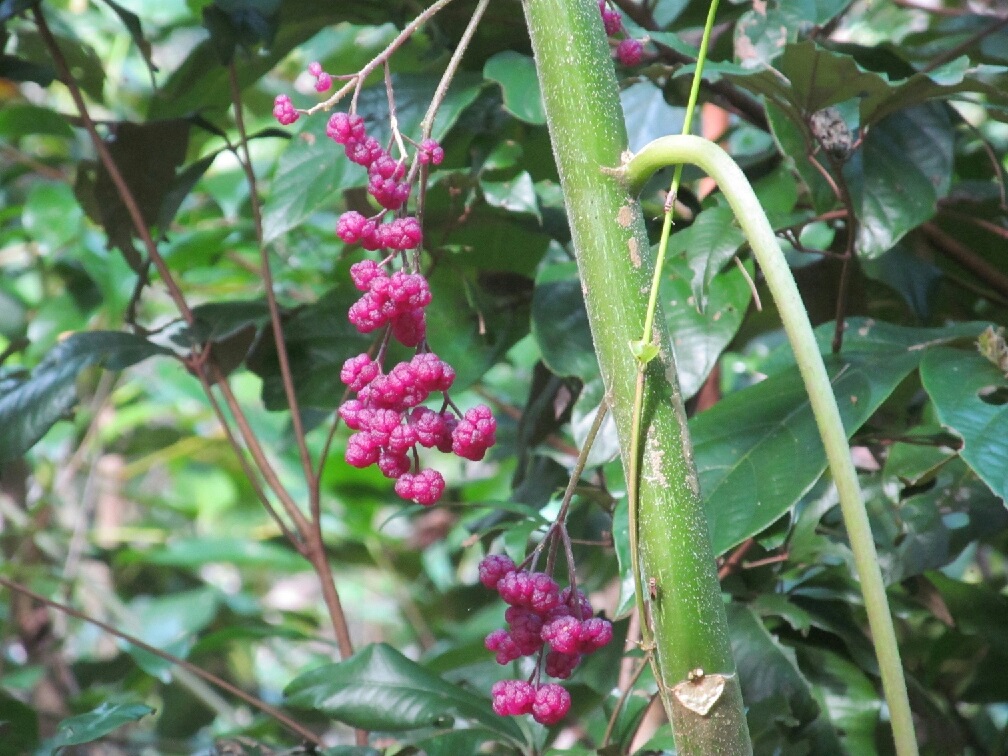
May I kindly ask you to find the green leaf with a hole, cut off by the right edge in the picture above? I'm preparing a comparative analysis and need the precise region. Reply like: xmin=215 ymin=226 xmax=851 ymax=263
xmin=920 ymin=348 xmax=1008 ymax=503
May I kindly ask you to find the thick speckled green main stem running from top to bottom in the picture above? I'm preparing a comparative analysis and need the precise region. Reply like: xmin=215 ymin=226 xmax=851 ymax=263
xmin=524 ymin=0 xmax=751 ymax=754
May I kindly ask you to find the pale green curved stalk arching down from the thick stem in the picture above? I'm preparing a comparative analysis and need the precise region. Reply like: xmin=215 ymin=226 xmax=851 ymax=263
xmin=621 ymin=136 xmax=917 ymax=756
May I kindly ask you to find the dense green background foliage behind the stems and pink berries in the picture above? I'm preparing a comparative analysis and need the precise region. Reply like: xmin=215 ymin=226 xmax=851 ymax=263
xmin=0 ymin=0 xmax=1008 ymax=754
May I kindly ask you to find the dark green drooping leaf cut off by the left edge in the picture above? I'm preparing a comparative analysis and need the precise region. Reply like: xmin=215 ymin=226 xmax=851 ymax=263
xmin=0 ymin=331 xmax=171 ymax=462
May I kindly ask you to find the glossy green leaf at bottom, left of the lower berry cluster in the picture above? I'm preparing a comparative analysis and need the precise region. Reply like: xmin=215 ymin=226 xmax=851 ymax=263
xmin=283 ymin=643 xmax=524 ymax=746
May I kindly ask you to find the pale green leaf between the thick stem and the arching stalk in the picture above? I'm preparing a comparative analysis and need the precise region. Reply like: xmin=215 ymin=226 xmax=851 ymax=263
xmin=661 ymin=258 xmax=752 ymax=399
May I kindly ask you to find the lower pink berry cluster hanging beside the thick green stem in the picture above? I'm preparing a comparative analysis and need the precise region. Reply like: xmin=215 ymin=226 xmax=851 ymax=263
xmin=480 ymin=554 xmax=613 ymax=725
